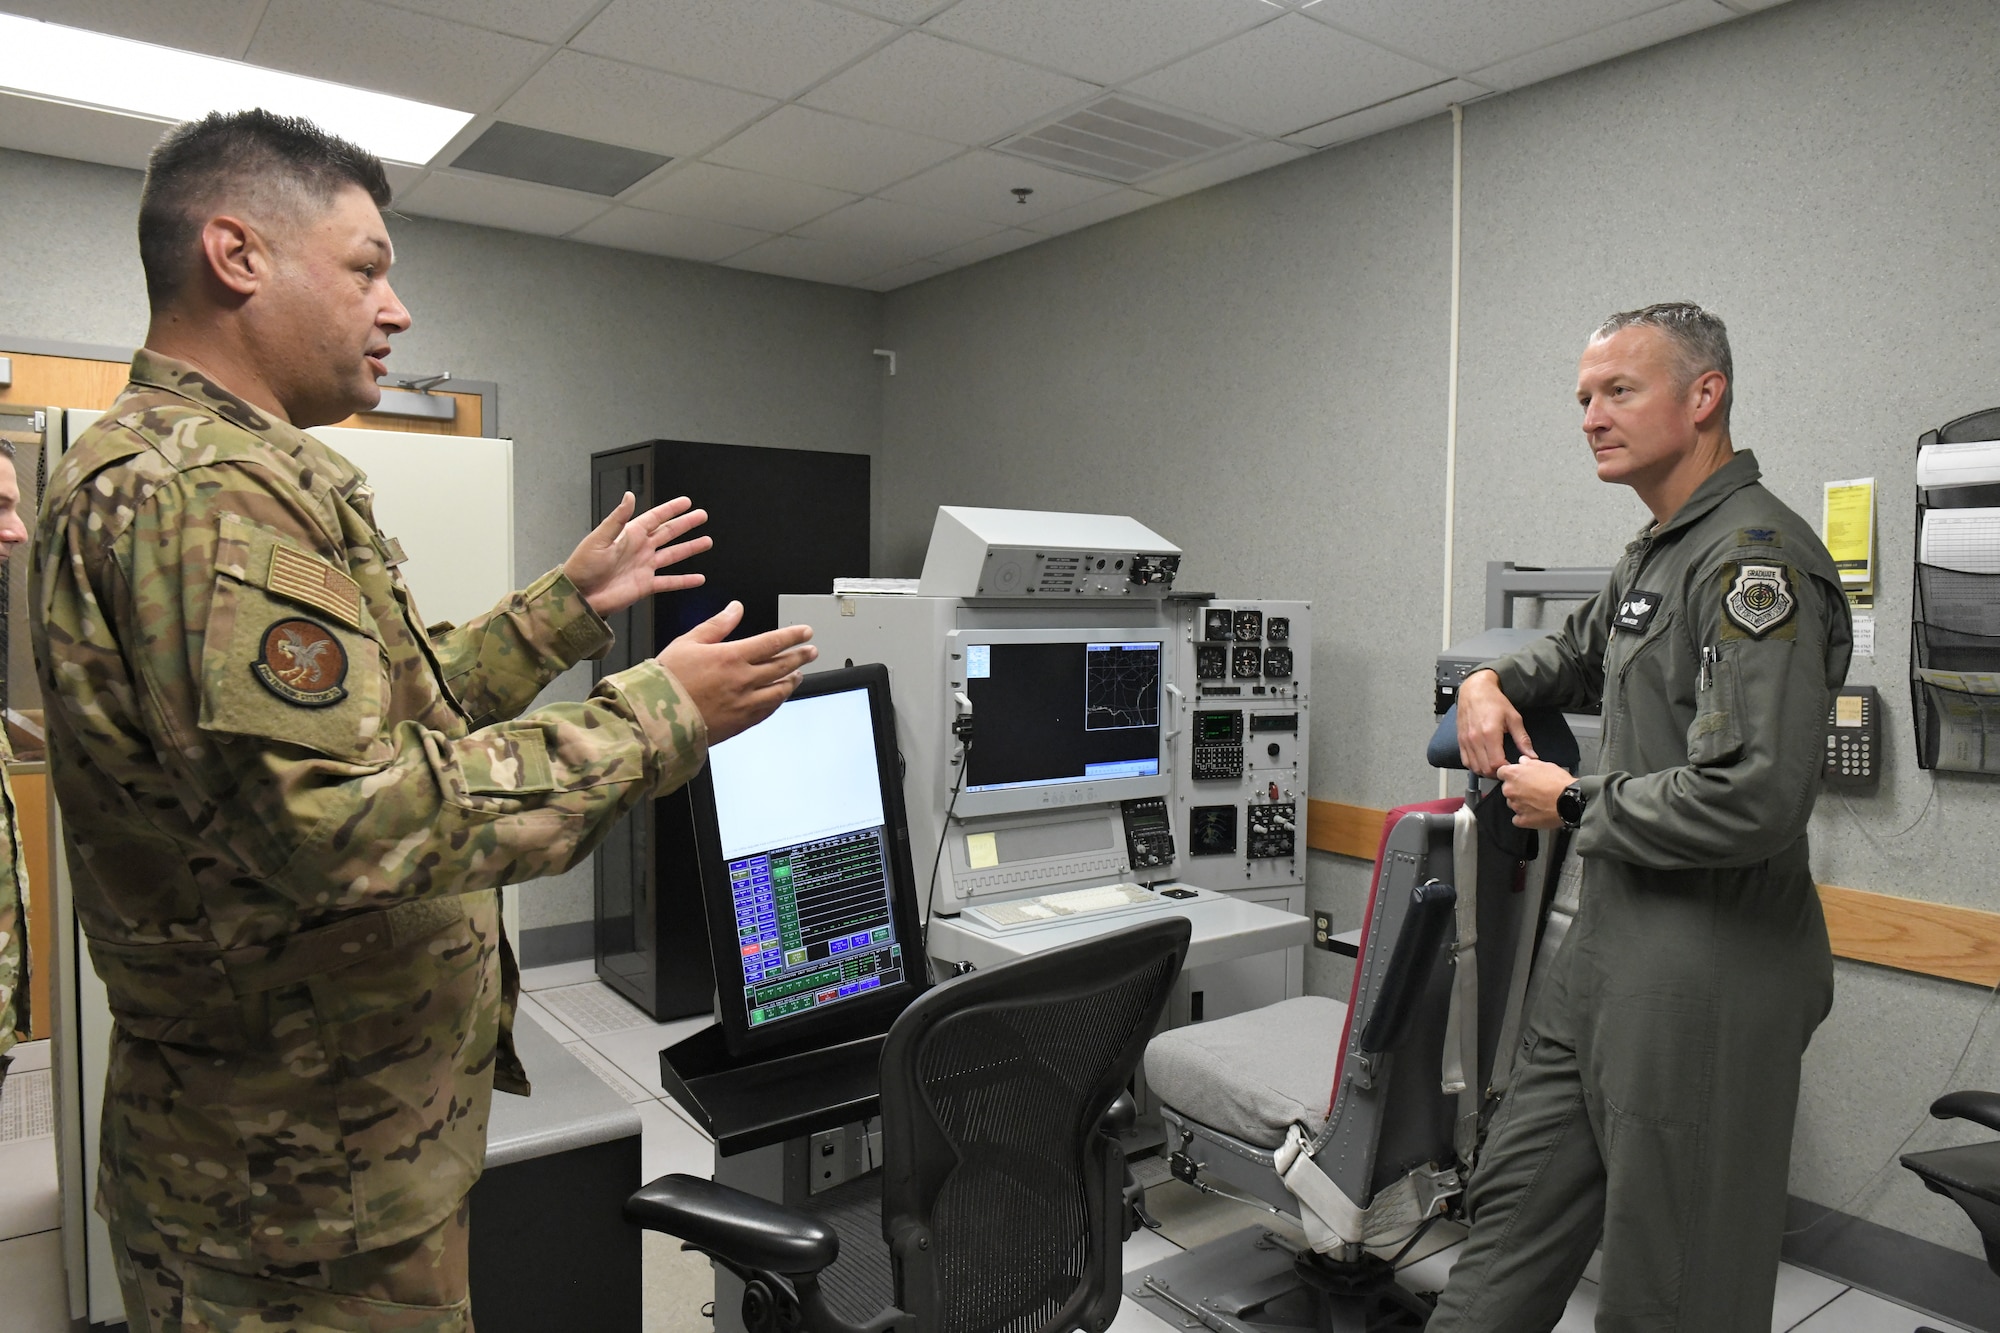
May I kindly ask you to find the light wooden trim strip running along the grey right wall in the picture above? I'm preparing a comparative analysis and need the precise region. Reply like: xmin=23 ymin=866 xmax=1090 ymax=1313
xmin=1306 ymin=801 xmax=2000 ymax=987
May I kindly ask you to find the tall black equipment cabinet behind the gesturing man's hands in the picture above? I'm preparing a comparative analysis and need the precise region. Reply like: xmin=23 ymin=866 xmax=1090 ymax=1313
xmin=590 ymin=440 xmax=870 ymax=1023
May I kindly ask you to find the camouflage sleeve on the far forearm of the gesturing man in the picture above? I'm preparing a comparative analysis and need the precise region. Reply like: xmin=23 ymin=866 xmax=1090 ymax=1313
xmin=430 ymin=568 xmax=612 ymax=727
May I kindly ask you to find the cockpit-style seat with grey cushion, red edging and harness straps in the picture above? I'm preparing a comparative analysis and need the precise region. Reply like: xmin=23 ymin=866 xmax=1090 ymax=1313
xmin=1132 ymin=713 xmax=1576 ymax=1333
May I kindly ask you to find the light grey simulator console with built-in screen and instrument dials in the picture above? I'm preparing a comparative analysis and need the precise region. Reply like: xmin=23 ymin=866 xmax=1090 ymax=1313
xmin=780 ymin=506 xmax=1312 ymax=1017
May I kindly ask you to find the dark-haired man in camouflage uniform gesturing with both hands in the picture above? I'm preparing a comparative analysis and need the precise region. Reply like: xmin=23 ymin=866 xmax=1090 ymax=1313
xmin=34 ymin=112 xmax=812 ymax=1333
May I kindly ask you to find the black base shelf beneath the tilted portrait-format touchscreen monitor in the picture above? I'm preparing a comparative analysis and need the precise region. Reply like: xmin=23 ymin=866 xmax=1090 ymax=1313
xmin=660 ymin=1023 xmax=888 ymax=1157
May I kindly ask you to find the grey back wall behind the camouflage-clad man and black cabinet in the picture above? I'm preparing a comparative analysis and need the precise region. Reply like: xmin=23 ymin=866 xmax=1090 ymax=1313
xmin=0 ymin=150 xmax=882 ymax=931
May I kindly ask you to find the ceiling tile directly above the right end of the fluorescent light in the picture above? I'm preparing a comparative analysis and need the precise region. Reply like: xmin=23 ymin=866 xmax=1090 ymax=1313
xmin=244 ymin=0 xmax=548 ymax=112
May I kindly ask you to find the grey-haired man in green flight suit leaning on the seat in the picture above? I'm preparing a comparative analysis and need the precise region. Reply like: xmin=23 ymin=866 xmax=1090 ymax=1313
xmin=1428 ymin=302 xmax=1852 ymax=1333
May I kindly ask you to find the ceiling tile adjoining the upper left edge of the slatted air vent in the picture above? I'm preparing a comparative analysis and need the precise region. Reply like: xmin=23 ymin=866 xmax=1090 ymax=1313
xmin=802 ymin=32 xmax=1100 ymax=144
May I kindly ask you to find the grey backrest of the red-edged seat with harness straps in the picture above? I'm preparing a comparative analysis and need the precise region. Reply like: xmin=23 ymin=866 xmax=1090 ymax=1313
xmin=1314 ymin=801 xmax=1552 ymax=1207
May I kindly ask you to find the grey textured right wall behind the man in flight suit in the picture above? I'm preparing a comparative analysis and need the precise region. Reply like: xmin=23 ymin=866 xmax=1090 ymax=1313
xmin=878 ymin=0 xmax=2000 ymax=1253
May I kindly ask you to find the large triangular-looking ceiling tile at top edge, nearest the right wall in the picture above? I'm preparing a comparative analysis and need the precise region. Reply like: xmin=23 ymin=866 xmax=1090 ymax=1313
xmin=1306 ymin=0 xmax=1660 ymax=74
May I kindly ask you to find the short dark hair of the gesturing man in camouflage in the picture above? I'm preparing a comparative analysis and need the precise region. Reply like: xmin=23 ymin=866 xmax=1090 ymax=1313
xmin=138 ymin=108 xmax=392 ymax=310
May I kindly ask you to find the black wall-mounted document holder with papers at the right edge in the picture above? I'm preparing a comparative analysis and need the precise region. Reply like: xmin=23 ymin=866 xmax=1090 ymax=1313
xmin=1910 ymin=408 xmax=2000 ymax=775
